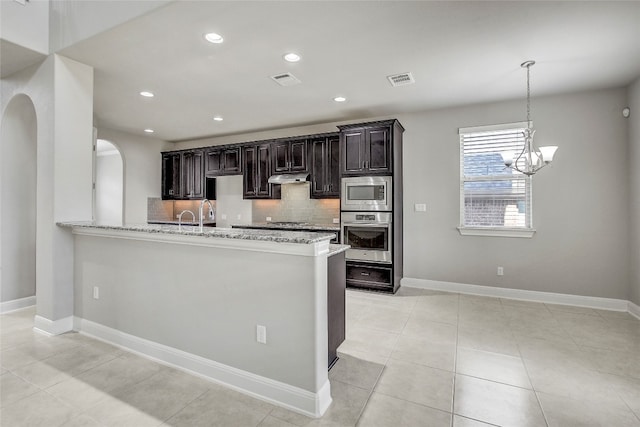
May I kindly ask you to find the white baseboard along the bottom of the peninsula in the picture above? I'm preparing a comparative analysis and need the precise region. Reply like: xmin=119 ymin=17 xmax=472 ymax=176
xmin=73 ymin=317 xmax=331 ymax=418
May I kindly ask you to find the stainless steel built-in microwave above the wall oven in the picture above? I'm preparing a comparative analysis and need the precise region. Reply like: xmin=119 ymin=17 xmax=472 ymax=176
xmin=340 ymin=176 xmax=393 ymax=211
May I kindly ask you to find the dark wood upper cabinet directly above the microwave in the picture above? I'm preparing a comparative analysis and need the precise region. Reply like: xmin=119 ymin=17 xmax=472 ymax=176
xmin=338 ymin=120 xmax=404 ymax=176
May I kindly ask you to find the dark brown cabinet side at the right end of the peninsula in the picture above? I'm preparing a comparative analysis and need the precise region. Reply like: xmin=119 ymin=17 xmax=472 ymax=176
xmin=327 ymin=252 xmax=346 ymax=369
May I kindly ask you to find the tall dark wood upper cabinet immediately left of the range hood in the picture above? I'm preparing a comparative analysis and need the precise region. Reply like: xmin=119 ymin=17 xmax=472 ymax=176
xmin=242 ymin=143 xmax=280 ymax=199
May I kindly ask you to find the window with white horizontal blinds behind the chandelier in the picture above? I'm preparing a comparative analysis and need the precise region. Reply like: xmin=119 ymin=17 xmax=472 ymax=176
xmin=458 ymin=122 xmax=535 ymax=237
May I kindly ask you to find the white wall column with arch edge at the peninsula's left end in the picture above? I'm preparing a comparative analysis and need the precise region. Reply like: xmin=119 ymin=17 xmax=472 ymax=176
xmin=0 ymin=55 xmax=93 ymax=331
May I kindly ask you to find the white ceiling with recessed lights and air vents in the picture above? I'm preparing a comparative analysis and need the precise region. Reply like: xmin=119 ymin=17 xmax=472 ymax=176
xmin=61 ymin=1 xmax=640 ymax=141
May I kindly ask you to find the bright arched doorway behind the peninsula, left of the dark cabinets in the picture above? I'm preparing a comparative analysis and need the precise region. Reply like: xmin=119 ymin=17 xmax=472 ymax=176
xmin=94 ymin=139 xmax=124 ymax=225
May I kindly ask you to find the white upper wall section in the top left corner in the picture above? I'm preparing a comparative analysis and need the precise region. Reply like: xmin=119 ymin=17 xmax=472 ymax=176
xmin=0 ymin=0 xmax=49 ymax=54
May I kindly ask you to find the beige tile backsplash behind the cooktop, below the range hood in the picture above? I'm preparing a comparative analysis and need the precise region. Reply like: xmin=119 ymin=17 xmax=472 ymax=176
xmin=252 ymin=182 xmax=340 ymax=224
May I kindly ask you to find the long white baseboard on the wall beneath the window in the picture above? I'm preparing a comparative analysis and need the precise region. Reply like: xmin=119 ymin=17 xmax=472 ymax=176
xmin=400 ymin=277 xmax=638 ymax=312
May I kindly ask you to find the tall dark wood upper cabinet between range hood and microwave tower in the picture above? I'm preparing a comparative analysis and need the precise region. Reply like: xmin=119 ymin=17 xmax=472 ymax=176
xmin=309 ymin=134 xmax=340 ymax=199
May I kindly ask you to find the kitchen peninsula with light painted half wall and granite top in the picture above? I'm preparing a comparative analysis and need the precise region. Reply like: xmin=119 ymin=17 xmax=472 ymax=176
xmin=58 ymin=223 xmax=346 ymax=417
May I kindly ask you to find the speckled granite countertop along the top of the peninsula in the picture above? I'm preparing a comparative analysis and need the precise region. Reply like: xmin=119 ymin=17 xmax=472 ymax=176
xmin=56 ymin=221 xmax=334 ymax=244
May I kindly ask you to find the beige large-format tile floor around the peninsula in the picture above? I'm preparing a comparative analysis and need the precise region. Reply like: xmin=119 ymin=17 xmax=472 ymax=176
xmin=0 ymin=288 xmax=640 ymax=427
